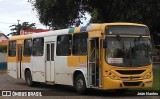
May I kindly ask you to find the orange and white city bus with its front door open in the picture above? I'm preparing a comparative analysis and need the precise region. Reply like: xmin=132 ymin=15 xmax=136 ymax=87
xmin=7 ymin=22 xmax=153 ymax=93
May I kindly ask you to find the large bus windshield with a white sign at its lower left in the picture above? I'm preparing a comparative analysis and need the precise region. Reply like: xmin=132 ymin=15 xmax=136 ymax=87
xmin=105 ymin=37 xmax=151 ymax=67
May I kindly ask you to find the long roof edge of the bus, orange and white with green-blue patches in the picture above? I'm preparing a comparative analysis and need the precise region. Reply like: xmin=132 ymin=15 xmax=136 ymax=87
xmin=9 ymin=22 xmax=147 ymax=40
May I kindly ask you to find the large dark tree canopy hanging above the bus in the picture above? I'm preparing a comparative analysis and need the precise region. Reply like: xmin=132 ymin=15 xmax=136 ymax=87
xmin=29 ymin=0 xmax=160 ymax=43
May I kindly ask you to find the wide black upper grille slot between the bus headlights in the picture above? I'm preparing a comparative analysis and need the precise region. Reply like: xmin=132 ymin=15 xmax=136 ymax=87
xmin=116 ymin=70 xmax=145 ymax=75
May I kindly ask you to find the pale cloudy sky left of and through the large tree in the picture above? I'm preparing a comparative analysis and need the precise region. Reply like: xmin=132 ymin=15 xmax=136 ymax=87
xmin=0 ymin=0 xmax=89 ymax=35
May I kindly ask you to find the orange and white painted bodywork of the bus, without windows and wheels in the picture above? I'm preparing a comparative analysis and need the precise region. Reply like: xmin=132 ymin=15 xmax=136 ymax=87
xmin=8 ymin=23 xmax=153 ymax=90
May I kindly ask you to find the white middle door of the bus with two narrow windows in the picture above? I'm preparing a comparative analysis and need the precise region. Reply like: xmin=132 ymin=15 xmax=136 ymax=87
xmin=45 ymin=42 xmax=55 ymax=82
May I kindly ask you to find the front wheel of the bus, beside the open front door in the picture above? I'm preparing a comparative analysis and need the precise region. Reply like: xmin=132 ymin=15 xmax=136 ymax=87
xmin=74 ymin=74 xmax=86 ymax=94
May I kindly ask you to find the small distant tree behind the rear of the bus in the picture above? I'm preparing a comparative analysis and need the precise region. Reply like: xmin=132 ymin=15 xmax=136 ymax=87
xmin=10 ymin=22 xmax=36 ymax=35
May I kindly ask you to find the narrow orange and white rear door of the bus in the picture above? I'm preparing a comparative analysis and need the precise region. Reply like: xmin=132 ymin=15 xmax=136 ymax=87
xmin=17 ymin=45 xmax=22 ymax=78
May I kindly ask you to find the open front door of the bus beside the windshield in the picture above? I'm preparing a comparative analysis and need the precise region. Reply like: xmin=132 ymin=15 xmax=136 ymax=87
xmin=88 ymin=38 xmax=100 ymax=87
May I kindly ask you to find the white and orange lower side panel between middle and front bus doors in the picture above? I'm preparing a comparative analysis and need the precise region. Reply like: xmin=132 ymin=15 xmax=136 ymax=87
xmin=55 ymin=56 xmax=87 ymax=85
